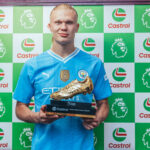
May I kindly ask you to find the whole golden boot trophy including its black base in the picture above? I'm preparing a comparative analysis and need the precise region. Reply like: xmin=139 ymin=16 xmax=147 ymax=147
xmin=46 ymin=77 xmax=96 ymax=118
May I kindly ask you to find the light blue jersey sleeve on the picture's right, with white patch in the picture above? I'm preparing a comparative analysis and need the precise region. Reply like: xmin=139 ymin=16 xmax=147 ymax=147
xmin=93 ymin=63 xmax=112 ymax=100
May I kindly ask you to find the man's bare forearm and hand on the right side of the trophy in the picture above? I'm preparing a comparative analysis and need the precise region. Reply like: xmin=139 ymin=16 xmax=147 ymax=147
xmin=83 ymin=99 xmax=109 ymax=130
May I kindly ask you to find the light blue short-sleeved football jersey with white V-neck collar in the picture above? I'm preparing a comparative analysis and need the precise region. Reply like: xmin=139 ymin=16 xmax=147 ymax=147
xmin=14 ymin=48 xmax=112 ymax=150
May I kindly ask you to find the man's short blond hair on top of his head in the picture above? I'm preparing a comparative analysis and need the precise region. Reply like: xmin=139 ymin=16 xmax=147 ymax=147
xmin=50 ymin=4 xmax=78 ymax=20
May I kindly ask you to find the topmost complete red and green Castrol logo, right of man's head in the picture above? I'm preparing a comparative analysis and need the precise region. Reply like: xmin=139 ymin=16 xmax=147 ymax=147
xmin=108 ymin=8 xmax=130 ymax=28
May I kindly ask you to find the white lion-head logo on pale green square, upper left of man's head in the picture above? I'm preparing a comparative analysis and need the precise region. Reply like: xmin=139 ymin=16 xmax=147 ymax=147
xmin=20 ymin=9 xmax=37 ymax=29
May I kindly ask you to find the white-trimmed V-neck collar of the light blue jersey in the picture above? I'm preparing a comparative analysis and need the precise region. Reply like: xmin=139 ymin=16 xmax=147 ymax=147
xmin=48 ymin=48 xmax=80 ymax=63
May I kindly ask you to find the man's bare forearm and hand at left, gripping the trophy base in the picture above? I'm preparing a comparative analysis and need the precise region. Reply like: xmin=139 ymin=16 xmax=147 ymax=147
xmin=16 ymin=101 xmax=63 ymax=124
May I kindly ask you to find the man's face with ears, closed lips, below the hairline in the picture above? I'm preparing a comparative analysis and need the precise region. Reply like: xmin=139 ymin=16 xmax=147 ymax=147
xmin=49 ymin=8 xmax=79 ymax=45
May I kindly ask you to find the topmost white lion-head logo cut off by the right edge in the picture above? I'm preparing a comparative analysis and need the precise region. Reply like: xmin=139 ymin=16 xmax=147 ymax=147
xmin=142 ymin=9 xmax=150 ymax=28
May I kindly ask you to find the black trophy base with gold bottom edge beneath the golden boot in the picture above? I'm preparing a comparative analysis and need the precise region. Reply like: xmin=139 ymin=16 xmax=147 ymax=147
xmin=46 ymin=100 xmax=96 ymax=118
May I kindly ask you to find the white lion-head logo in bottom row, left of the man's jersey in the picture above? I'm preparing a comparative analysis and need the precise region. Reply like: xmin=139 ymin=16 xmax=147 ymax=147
xmin=19 ymin=128 xmax=33 ymax=148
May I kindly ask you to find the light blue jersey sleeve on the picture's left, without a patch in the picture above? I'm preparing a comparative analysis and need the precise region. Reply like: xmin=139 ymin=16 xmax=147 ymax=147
xmin=13 ymin=60 xmax=34 ymax=104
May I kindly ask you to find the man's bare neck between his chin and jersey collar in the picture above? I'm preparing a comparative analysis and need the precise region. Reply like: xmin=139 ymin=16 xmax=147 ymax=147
xmin=51 ymin=42 xmax=76 ymax=58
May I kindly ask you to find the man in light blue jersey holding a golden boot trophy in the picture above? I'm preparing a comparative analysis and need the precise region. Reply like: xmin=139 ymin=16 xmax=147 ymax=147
xmin=14 ymin=4 xmax=111 ymax=150
